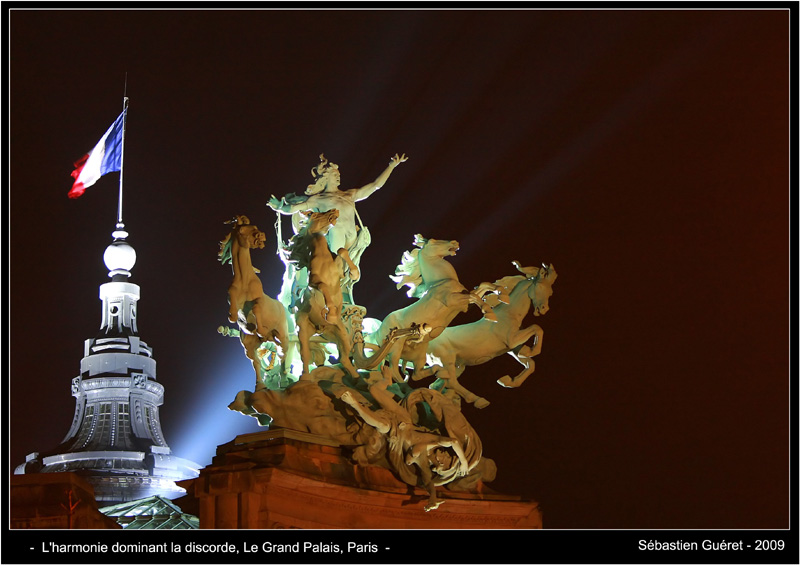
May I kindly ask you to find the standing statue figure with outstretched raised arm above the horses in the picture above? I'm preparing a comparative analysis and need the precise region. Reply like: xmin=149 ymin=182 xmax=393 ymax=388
xmin=267 ymin=153 xmax=408 ymax=303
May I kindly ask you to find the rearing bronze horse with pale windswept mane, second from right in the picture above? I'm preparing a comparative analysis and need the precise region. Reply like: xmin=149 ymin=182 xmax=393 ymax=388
xmin=373 ymin=234 xmax=492 ymax=382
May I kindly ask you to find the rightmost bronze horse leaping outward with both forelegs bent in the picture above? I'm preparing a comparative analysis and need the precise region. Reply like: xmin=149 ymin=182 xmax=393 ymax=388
xmin=422 ymin=261 xmax=558 ymax=408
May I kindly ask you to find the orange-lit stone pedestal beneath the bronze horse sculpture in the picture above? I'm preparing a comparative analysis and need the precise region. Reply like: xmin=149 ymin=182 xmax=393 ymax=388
xmin=181 ymin=430 xmax=542 ymax=530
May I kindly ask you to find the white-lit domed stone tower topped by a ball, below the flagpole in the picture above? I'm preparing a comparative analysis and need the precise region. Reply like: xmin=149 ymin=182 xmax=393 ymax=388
xmin=15 ymin=223 xmax=200 ymax=505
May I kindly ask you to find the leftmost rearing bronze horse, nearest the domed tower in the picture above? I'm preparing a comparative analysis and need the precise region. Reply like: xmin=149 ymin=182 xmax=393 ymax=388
xmin=217 ymin=216 xmax=289 ymax=390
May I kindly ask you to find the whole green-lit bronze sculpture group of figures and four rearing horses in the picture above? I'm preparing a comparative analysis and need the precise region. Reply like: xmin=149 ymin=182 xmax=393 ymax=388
xmin=219 ymin=155 xmax=557 ymax=510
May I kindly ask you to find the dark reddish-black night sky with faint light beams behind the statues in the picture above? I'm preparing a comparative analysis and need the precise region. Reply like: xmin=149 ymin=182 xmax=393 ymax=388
xmin=6 ymin=9 xmax=791 ymax=529
